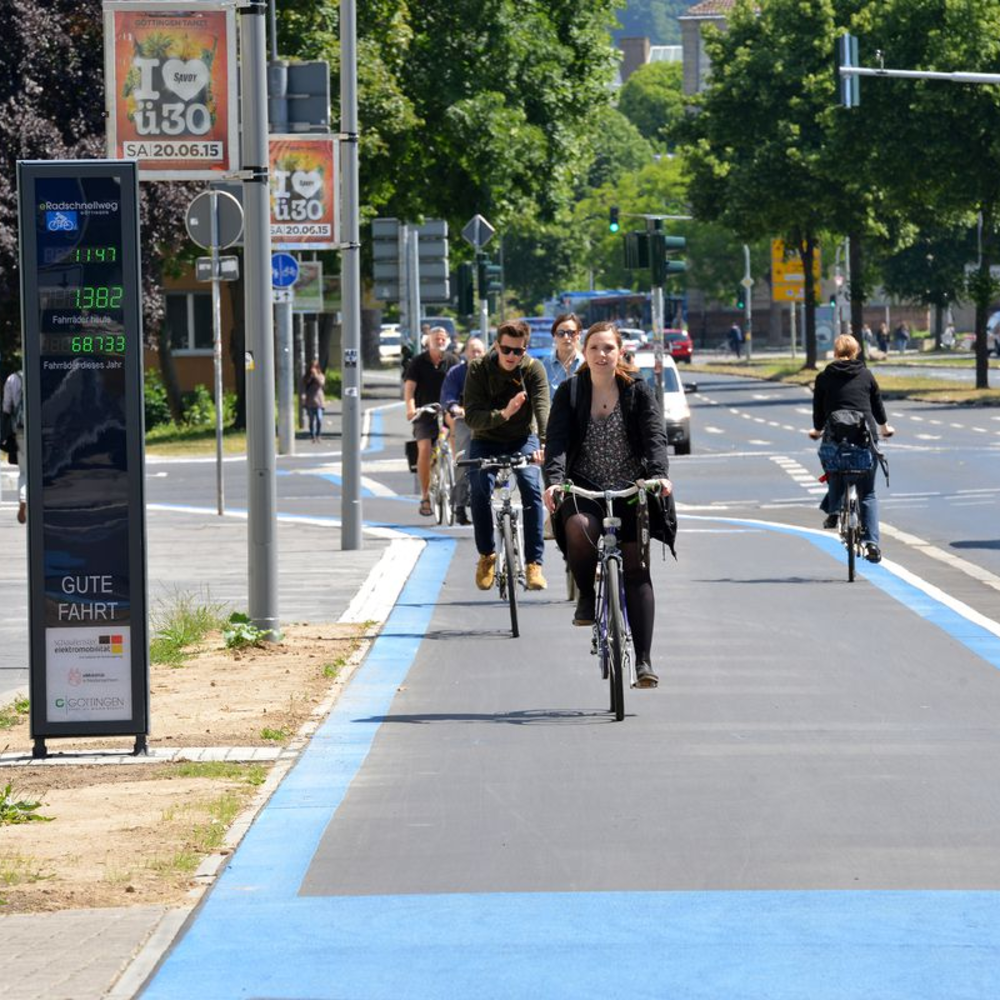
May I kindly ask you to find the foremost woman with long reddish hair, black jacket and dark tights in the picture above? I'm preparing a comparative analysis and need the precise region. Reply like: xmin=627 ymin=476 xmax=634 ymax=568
xmin=544 ymin=323 xmax=676 ymax=687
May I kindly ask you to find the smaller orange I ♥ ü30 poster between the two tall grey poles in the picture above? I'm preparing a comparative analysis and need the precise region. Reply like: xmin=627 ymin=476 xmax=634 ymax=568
xmin=268 ymin=135 xmax=340 ymax=250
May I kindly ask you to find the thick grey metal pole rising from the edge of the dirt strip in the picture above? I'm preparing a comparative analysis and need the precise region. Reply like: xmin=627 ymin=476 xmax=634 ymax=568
xmin=240 ymin=0 xmax=280 ymax=636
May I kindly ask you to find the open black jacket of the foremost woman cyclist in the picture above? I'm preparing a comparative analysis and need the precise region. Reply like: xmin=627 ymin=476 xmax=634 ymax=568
xmin=543 ymin=369 xmax=677 ymax=551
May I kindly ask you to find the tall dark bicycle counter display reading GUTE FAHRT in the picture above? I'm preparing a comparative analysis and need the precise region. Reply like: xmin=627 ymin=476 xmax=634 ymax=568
xmin=18 ymin=160 xmax=149 ymax=756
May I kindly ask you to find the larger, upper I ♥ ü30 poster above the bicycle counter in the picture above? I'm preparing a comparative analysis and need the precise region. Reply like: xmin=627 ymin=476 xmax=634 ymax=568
xmin=104 ymin=0 xmax=239 ymax=180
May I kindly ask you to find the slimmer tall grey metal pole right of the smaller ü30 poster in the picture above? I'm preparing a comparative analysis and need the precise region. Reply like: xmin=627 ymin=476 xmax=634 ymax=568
xmin=340 ymin=0 xmax=362 ymax=551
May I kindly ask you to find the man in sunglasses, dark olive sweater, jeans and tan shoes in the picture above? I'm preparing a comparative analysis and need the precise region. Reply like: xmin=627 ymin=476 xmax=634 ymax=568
xmin=465 ymin=320 xmax=549 ymax=590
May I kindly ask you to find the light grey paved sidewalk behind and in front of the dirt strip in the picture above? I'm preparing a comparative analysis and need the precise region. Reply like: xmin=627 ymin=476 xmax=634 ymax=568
xmin=0 ymin=491 xmax=420 ymax=1000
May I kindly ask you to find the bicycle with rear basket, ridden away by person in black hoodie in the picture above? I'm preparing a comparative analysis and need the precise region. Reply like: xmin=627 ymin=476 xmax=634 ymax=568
xmin=809 ymin=410 xmax=895 ymax=583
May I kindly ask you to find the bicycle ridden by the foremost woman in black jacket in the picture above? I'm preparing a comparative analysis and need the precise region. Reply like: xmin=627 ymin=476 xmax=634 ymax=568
xmin=558 ymin=480 xmax=660 ymax=722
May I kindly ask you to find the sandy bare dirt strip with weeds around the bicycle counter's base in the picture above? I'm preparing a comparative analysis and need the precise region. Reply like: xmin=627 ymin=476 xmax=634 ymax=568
xmin=0 ymin=625 xmax=366 ymax=913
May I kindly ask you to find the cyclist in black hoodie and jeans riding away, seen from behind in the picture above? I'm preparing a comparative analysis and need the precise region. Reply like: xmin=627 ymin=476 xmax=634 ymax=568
xmin=809 ymin=333 xmax=894 ymax=563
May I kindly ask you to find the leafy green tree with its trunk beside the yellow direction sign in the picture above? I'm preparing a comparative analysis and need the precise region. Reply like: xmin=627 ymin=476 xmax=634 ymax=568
xmin=677 ymin=0 xmax=843 ymax=368
